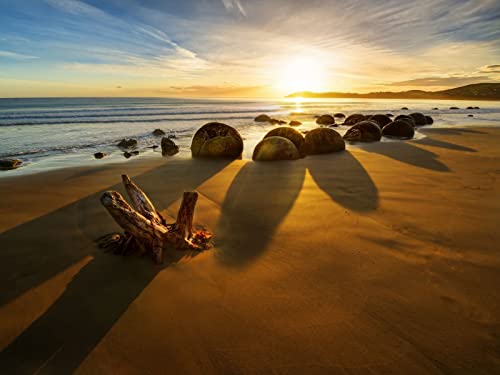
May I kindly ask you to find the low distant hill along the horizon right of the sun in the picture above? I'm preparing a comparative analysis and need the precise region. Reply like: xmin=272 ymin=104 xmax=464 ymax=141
xmin=287 ymin=83 xmax=500 ymax=100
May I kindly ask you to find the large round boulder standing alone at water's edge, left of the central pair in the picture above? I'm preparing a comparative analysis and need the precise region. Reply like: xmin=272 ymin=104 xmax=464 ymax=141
xmin=191 ymin=122 xmax=243 ymax=159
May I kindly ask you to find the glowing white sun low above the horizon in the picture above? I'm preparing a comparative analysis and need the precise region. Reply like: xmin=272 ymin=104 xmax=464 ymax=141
xmin=276 ymin=58 xmax=327 ymax=93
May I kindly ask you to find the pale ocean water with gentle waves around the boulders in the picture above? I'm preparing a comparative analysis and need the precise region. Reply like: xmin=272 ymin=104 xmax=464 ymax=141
xmin=0 ymin=98 xmax=500 ymax=177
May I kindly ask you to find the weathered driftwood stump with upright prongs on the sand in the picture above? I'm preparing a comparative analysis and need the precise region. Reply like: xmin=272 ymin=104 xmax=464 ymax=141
xmin=98 ymin=175 xmax=211 ymax=263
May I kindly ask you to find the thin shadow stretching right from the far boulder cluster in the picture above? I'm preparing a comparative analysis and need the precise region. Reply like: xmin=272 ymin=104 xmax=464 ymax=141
xmin=360 ymin=141 xmax=450 ymax=172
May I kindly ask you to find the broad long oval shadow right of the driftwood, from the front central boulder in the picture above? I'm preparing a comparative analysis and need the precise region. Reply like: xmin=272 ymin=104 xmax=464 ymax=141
xmin=215 ymin=161 xmax=305 ymax=266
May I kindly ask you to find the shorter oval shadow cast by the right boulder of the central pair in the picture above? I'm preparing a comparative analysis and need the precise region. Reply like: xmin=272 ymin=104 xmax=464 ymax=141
xmin=307 ymin=151 xmax=379 ymax=212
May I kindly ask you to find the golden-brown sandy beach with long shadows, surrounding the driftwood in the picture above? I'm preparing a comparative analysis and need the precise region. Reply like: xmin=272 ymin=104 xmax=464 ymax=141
xmin=0 ymin=127 xmax=500 ymax=374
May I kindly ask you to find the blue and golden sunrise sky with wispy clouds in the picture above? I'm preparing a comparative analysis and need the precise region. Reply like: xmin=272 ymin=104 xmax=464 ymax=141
xmin=0 ymin=0 xmax=500 ymax=98
